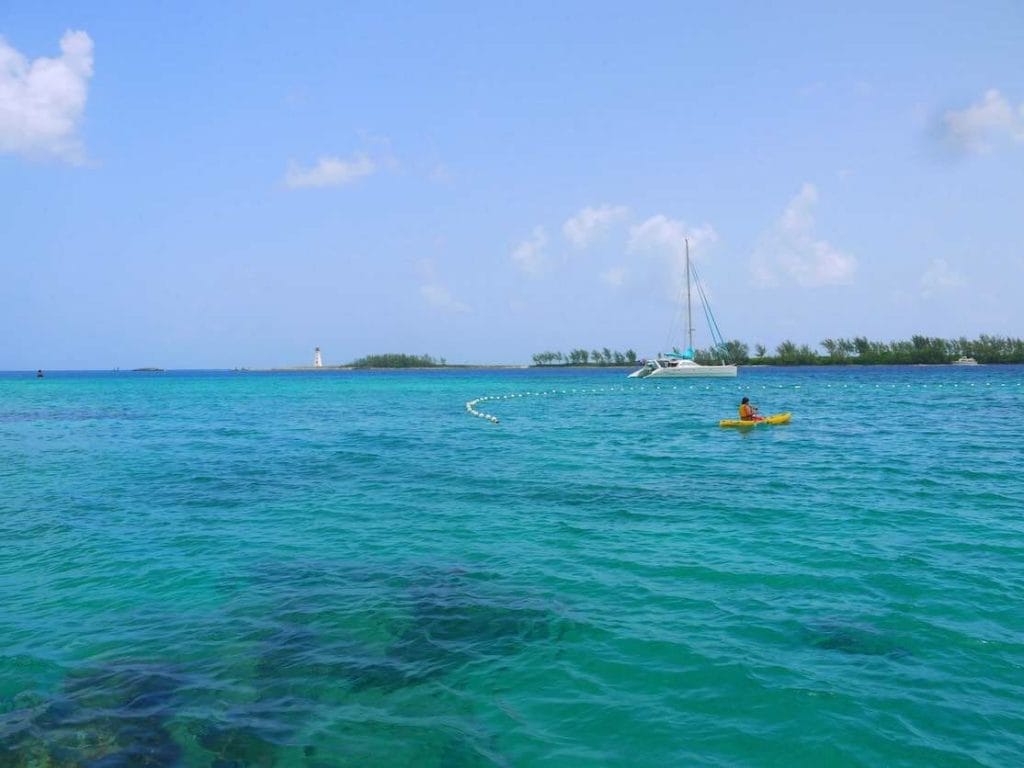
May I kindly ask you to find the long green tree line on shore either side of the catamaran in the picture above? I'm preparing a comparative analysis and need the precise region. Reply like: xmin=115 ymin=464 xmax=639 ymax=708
xmin=534 ymin=334 xmax=1024 ymax=366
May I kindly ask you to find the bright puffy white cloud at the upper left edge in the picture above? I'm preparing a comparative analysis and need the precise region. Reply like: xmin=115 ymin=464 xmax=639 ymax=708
xmin=0 ymin=31 xmax=92 ymax=164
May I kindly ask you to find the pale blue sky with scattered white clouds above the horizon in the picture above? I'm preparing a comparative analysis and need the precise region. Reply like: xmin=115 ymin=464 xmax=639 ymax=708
xmin=0 ymin=0 xmax=1024 ymax=370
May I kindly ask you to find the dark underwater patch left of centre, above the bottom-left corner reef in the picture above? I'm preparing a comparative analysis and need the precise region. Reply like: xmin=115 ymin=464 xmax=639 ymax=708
xmin=239 ymin=563 xmax=565 ymax=695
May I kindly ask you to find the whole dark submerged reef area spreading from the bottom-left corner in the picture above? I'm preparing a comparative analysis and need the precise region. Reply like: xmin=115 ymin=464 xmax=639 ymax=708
xmin=0 ymin=563 xmax=567 ymax=768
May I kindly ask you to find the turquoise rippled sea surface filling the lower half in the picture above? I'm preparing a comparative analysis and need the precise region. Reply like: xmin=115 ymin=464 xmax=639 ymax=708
xmin=0 ymin=366 xmax=1024 ymax=768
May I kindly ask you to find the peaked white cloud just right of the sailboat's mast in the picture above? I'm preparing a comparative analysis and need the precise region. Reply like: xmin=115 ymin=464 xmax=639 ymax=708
xmin=752 ymin=183 xmax=857 ymax=288
